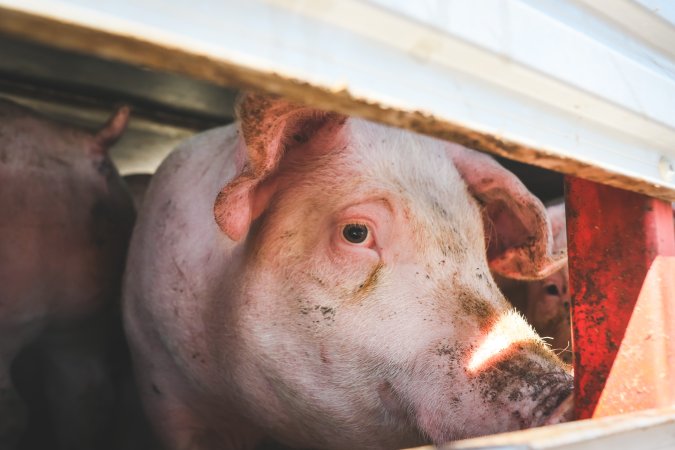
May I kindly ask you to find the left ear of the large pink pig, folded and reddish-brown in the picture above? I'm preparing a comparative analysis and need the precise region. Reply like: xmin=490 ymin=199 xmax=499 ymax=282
xmin=213 ymin=93 xmax=346 ymax=241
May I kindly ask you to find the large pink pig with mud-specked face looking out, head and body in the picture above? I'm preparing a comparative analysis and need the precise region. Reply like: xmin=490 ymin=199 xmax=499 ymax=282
xmin=123 ymin=93 xmax=572 ymax=449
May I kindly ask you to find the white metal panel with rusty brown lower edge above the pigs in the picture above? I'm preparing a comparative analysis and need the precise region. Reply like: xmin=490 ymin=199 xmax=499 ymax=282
xmin=0 ymin=0 xmax=675 ymax=199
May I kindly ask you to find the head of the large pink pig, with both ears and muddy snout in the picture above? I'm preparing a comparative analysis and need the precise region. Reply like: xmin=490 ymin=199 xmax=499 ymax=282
xmin=214 ymin=94 xmax=572 ymax=448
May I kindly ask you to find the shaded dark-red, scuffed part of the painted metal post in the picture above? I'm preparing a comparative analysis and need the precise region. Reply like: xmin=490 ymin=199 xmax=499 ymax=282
xmin=565 ymin=177 xmax=675 ymax=419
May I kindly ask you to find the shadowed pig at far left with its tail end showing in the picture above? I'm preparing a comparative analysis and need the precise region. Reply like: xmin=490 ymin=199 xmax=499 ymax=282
xmin=0 ymin=99 xmax=135 ymax=449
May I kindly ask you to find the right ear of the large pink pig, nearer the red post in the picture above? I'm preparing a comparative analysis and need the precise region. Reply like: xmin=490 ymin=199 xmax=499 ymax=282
xmin=448 ymin=144 xmax=566 ymax=280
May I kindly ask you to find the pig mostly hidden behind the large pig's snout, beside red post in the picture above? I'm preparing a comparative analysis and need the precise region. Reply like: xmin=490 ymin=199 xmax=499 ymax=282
xmin=495 ymin=201 xmax=573 ymax=363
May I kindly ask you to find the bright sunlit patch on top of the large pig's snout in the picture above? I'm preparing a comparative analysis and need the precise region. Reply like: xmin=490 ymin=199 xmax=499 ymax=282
xmin=467 ymin=310 xmax=541 ymax=373
